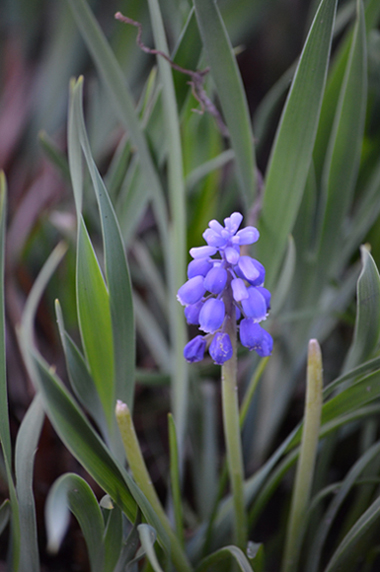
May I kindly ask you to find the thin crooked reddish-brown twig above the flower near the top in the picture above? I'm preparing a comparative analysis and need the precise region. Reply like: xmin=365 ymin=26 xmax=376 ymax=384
xmin=115 ymin=12 xmax=229 ymax=137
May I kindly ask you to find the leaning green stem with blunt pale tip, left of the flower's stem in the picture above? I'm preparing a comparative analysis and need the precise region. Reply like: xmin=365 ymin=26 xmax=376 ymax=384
xmin=116 ymin=401 xmax=192 ymax=572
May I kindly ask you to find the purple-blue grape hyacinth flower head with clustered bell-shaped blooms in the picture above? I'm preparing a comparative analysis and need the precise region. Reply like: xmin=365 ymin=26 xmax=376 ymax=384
xmin=177 ymin=212 xmax=273 ymax=365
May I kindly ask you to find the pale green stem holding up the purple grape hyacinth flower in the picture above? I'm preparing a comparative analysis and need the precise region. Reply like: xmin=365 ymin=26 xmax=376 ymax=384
xmin=222 ymin=288 xmax=247 ymax=550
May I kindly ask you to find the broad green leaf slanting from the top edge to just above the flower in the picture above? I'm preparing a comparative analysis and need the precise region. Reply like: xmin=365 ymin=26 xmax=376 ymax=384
xmin=193 ymin=0 xmax=256 ymax=208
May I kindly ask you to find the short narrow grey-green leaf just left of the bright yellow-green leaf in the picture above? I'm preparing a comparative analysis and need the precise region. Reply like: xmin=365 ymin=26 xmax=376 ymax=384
xmin=55 ymin=300 xmax=108 ymax=435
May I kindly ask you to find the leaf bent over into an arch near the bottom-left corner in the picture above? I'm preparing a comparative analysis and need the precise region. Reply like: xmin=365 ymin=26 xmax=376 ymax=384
xmin=45 ymin=473 xmax=104 ymax=572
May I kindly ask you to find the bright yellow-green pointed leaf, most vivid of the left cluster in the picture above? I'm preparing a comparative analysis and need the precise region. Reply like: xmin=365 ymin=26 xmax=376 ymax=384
xmin=76 ymin=217 xmax=115 ymax=424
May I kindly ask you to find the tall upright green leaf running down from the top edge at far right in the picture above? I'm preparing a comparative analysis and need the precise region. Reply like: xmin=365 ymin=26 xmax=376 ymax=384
xmin=318 ymin=0 xmax=367 ymax=277
